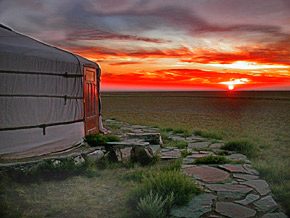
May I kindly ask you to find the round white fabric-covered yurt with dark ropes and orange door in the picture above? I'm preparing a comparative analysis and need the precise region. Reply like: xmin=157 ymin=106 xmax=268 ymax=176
xmin=0 ymin=24 xmax=102 ymax=158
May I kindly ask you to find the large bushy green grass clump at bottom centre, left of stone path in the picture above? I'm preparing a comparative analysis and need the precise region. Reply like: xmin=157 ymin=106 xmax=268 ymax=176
xmin=128 ymin=171 xmax=201 ymax=217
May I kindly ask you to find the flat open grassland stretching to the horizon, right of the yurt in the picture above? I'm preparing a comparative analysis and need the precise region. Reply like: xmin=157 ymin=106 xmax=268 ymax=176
xmin=102 ymin=91 xmax=290 ymax=213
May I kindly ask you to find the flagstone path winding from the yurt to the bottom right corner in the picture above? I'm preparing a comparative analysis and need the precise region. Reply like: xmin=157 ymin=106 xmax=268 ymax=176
xmin=106 ymin=120 xmax=287 ymax=218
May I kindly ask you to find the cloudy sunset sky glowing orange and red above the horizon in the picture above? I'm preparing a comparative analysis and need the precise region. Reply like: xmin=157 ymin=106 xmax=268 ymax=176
xmin=0 ymin=0 xmax=290 ymax=91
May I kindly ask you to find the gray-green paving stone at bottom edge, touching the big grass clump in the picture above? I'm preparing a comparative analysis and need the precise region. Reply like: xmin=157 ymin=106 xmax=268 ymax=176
xmin=170 ymin=194 xmax=216 ymax=218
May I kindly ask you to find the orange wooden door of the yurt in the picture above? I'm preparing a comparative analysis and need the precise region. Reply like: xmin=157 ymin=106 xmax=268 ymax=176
xmin=84 ymin=67 xmax=99 ymax=135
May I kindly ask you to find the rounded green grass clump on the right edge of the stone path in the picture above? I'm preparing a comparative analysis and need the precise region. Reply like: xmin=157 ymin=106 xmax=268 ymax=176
xmin=221 ymin=140 xmax=257 ymax=157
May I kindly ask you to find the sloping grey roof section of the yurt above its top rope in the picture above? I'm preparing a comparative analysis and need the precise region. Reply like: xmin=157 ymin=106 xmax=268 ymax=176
xmin=0 ymin=24 xmax=98 ymax=74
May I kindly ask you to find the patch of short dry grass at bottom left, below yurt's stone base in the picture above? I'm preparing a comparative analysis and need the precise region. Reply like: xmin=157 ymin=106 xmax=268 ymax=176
xmin=4 ymin=168 xmax=130 ymax=218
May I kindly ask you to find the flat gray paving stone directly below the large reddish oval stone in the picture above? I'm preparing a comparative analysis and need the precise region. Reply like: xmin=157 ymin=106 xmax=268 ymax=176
xmin=206 ymin=183 xmax=253 ymax=199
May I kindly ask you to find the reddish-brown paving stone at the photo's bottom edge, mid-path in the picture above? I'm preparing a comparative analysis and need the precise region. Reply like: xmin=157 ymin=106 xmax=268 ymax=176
xmin=215 ymin=202 xmax=256 ymax=218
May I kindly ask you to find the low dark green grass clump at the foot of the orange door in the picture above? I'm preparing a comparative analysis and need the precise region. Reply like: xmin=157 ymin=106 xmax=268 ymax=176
xmin=85 ymin=133 xmax=121 ymax=147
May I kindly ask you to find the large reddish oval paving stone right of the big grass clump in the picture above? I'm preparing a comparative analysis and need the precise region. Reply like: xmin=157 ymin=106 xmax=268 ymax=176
xmin=183 ymin=166 xmax=230 ymax=183
